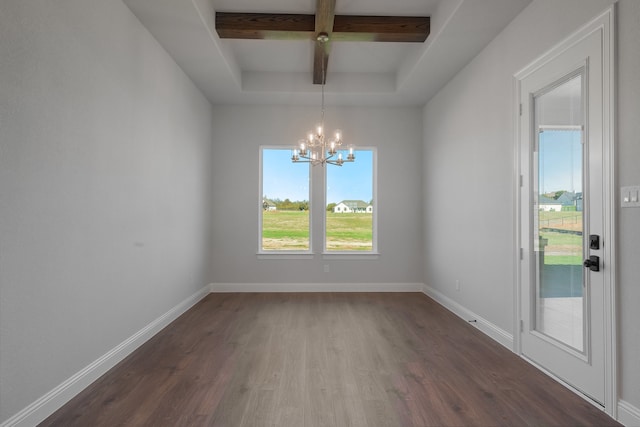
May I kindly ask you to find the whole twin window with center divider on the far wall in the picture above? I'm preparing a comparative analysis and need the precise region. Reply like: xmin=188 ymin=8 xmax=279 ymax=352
xmin=258 ymin=146 xmax=377 ymax=258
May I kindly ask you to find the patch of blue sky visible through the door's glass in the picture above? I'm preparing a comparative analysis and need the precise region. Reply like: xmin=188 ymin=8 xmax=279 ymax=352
xmin=539 ymin=130 xmax=582 ymax=194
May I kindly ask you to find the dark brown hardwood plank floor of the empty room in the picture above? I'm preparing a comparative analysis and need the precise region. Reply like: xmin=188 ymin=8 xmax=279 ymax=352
xmin=41 ymin=293 xmax=619 ymax=427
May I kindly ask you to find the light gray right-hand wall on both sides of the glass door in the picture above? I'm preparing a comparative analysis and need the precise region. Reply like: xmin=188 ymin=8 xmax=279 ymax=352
xmin=423 ymin=0 xmax=640 ymax=414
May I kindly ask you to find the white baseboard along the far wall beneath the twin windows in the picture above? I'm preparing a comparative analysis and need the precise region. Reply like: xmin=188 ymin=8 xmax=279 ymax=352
xmin=211 ymin=283 xmax=423 ymax=293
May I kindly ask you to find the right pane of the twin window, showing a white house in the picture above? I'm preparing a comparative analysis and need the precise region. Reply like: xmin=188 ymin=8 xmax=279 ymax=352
xmin=325 ymin=150 xmax=375 ymax=252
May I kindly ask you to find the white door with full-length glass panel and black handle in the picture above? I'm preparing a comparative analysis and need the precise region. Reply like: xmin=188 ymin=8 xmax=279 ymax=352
xmin=516 ymin=11 xmax=613 ymax=405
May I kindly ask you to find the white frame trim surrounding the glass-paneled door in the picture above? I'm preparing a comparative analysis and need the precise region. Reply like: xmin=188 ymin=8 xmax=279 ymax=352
xmin=513 ymin=4 xmax=618 ymax=419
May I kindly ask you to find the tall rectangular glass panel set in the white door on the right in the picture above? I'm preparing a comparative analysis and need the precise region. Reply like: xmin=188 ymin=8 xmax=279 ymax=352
xmin=532 ymin=73 xmax=586 ymax=353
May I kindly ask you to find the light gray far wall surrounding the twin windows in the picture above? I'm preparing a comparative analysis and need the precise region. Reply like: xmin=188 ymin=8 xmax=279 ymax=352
xmin=213 ymin=105 xmax=422 ymax=283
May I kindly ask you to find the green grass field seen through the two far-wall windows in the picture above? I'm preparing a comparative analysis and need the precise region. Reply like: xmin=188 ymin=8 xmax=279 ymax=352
xmin=262 ymin=211 xmax=373 ymax=251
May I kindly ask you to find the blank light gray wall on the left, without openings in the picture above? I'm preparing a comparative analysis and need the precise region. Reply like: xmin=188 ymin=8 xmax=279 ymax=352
xmin=0 ymin=0 xmax=212 ymax=422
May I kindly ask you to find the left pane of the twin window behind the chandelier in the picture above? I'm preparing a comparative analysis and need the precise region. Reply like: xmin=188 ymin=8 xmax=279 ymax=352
xmin=260 ymin=148 xmax=310 ymax=251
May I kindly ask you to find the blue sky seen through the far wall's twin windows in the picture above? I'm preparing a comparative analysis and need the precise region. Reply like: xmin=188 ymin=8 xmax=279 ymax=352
xmin=262 ymin=149 xmax=373 ymax=204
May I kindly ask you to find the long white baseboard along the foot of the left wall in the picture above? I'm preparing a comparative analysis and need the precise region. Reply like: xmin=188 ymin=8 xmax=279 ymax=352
xmin=0 ymin=285 xmax=211 ymax=427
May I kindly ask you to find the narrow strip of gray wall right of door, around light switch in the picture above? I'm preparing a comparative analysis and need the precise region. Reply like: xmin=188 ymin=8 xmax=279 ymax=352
xmin=616 ymin=0 xmax=640 ymax=420
